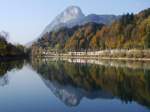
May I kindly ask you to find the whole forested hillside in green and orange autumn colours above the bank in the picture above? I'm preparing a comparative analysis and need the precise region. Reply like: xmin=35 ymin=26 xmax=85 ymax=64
xmin=31 ymin=9 xmax=150 ymax=55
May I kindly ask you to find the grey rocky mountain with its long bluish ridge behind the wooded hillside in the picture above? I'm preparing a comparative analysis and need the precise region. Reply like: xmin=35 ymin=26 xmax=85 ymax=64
xmin=40 ymin=6 xmax=118 ymax=37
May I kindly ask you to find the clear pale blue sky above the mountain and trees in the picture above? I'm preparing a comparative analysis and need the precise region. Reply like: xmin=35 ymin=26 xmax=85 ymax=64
xmin=0 ymin=0 xmax=150 ymax=44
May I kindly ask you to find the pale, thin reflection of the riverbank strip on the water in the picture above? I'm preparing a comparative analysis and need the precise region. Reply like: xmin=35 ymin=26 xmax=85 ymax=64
xmin=33 ymin=56 xmax=150 ymax=69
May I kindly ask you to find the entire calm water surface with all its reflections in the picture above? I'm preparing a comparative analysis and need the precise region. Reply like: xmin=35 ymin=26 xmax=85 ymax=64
xmin=0 ymin=59 xmax=150 ymax=112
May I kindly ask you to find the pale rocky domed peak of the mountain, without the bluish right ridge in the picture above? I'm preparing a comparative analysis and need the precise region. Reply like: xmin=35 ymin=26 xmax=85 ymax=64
xmin=42 ymin=6 xmax=85 ymax=34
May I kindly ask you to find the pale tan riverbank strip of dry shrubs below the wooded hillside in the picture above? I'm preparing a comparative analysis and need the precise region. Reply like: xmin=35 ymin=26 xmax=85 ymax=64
xmin=37 ymin=49 xmax=150 ymax=61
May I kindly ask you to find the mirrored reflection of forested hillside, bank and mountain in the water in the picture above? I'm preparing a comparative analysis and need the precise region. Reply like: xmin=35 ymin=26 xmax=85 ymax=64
xmin=32 ymin=59 xmax=150 ymax=108
